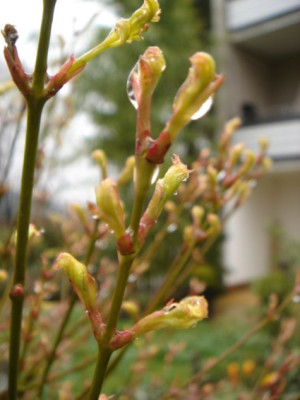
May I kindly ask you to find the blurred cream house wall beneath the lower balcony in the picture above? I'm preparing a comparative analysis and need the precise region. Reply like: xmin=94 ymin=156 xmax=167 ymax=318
xmin=224 ymin=171 xmax=300 ymax=285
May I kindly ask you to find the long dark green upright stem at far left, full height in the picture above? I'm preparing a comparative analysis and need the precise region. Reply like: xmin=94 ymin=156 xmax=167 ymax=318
xmin=8 ymin=0 xmax=55 ymax=400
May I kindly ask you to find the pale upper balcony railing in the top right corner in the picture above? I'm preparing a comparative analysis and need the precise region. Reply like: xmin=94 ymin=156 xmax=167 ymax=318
xmin=226 ymin=0 xmax=300 ymax=31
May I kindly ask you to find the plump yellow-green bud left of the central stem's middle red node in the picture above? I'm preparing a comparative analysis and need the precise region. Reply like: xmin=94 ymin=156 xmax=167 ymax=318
xmin=96 ymin=178 xmax=125 ymax=239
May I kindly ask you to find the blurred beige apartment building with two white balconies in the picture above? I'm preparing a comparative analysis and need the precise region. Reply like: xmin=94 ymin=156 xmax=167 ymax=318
xmin=211 ymin=0 xmax=300 ymax=285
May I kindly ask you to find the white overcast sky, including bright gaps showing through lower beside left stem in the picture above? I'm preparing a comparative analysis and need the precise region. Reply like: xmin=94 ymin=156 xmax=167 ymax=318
xmin=0 ymin=0 xmax=116 ymax=203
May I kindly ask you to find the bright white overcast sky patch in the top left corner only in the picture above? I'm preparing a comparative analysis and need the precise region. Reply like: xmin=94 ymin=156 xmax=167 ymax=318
xmin=0 ymin=0 xmax=115 ymax=69
